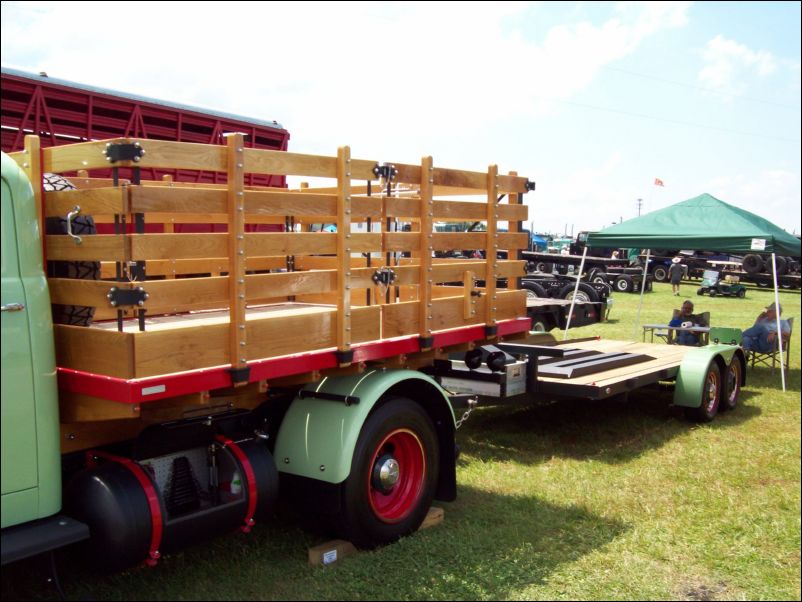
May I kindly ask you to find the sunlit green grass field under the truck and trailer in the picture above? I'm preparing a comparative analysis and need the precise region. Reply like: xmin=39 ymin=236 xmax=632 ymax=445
xmin=2 ymin=284 xmax=800 ymax=600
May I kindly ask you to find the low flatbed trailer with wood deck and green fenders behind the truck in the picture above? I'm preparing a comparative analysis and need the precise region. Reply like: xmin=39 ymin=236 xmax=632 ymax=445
xmin=428 ymin=334 xmax=746 ymax=422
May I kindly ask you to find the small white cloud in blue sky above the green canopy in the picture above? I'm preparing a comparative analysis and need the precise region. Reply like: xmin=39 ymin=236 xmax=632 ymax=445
xmin=699 ymin=35 xmax=777 ymax=94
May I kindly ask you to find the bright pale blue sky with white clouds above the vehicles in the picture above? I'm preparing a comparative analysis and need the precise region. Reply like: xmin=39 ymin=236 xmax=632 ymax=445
xmin=2 ymin=2 xmax=802 ymax=234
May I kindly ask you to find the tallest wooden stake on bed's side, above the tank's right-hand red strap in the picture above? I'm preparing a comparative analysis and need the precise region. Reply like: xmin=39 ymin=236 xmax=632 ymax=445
xmin=226 ymin=133 xmax=248 ymax=386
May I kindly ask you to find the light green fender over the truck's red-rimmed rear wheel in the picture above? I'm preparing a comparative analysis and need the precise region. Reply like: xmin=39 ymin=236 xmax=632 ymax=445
xmin=274 ymin=370 xmax=455 ymax=484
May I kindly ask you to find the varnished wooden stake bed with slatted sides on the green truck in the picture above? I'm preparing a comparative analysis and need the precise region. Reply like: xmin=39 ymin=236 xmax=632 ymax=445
xmin=13 ymin=134 xmax=529 ymax=403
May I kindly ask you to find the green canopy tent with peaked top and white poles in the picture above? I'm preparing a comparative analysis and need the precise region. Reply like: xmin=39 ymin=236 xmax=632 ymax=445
xmin=587 ymin=194 xmax=802 ymax=390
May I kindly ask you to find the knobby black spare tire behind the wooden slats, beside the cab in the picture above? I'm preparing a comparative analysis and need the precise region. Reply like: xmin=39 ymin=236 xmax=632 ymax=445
xmin=43 ymin=174 xmax=100 ymax=326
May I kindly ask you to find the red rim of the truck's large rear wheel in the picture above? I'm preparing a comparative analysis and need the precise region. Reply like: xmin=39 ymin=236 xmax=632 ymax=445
xmin=367 ymin=429 xmax=426 ymax=523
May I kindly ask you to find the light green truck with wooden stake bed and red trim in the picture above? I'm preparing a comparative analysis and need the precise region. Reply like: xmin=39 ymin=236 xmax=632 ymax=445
xmin=2 ymin=134 xmax=531 ymax=568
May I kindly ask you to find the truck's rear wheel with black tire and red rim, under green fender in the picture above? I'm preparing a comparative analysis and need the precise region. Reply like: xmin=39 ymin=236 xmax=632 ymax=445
xmin=335 ymin=397 xmax=440 ymax=548
